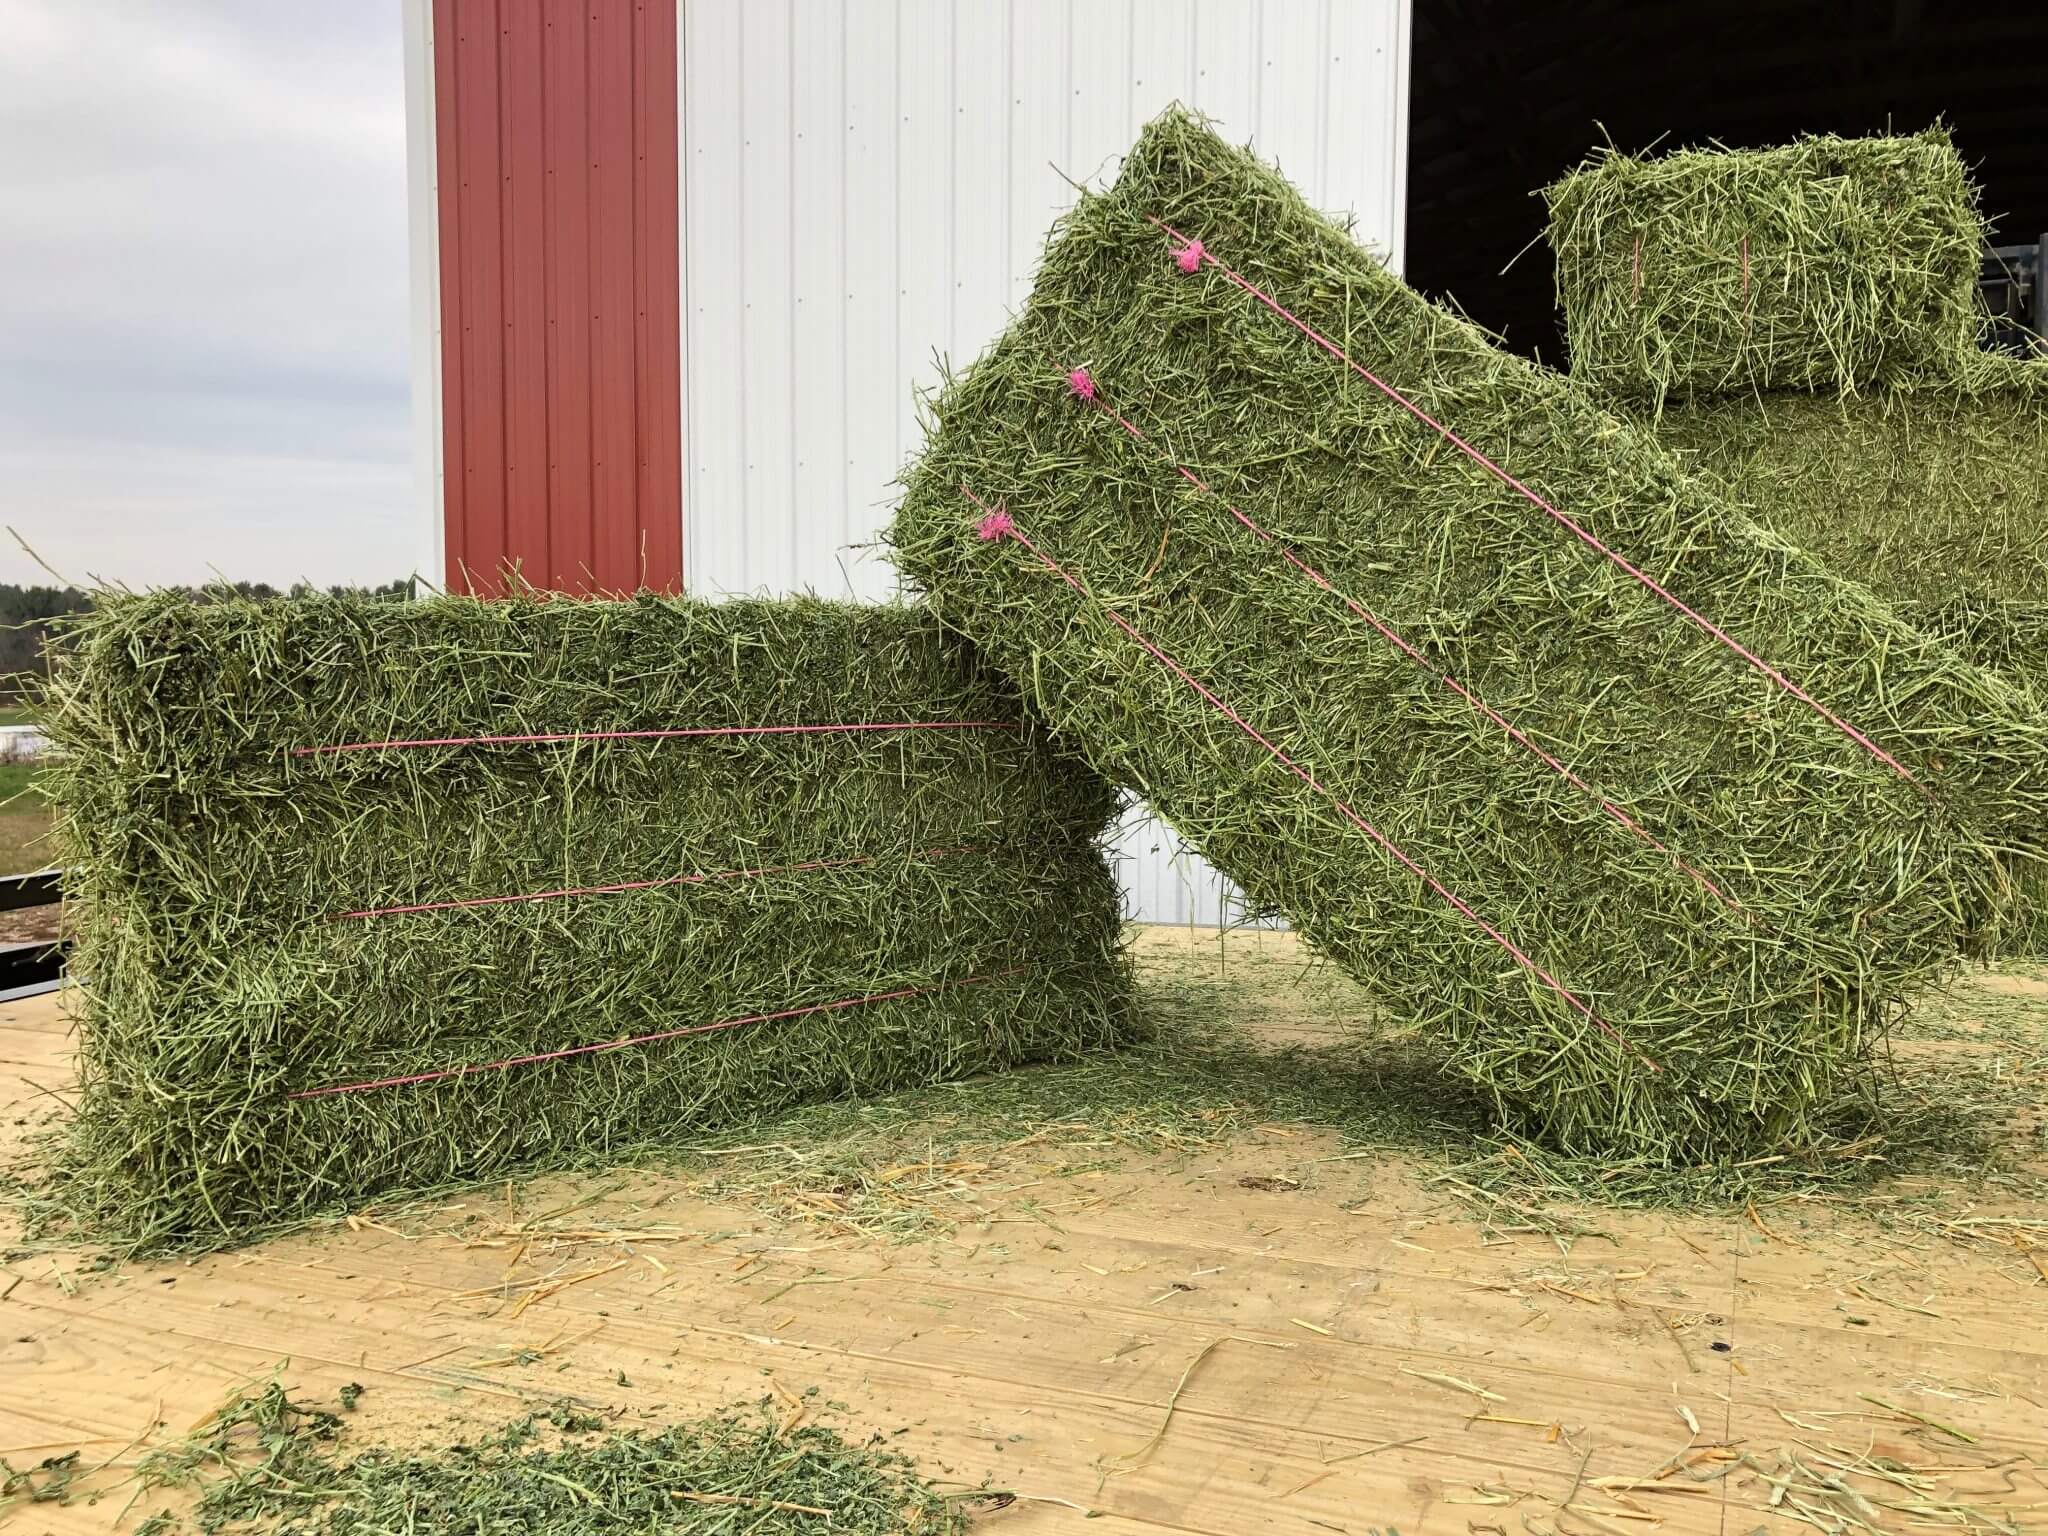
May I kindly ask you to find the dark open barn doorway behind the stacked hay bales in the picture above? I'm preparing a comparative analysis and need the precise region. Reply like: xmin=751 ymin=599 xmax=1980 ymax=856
xmin=1407 ymin=0 xmax=2048 ymax=367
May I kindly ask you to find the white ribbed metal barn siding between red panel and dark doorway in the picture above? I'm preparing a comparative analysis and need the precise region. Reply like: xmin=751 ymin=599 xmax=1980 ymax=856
xmin=678 ymin=0 xmax=1409 ymax=922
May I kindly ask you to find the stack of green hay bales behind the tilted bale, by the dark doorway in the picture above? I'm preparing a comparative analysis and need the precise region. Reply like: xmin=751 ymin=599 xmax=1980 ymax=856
xmin=1544 ymin=129 xmax=2048 ymax=948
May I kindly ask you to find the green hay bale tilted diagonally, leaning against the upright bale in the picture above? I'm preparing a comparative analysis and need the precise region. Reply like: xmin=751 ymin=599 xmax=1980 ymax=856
xmin=891 ymin=111 xmax=2048 ymax=1165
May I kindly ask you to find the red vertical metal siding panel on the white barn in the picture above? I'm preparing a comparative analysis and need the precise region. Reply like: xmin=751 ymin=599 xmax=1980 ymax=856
xmin=434 ymin=0 xmax=682 ymax=594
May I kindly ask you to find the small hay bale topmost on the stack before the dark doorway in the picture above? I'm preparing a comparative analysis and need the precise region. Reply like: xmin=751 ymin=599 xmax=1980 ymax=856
xmin=1544 ymin=127 xmax=1985 ymax=403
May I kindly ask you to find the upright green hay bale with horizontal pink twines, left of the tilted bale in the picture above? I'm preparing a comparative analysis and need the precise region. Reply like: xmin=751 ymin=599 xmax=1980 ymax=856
xmin=45 ymin=594 xmax=1130 ymax=1245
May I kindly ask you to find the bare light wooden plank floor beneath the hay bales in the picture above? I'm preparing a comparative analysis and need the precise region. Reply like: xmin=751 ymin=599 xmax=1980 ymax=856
xmin=0 ymin=930 xmax=2048 ymax=1536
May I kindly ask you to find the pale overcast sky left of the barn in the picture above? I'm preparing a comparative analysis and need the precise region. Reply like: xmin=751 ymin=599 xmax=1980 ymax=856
xmin=0 ymin=0 xmax=422 ymax=586
